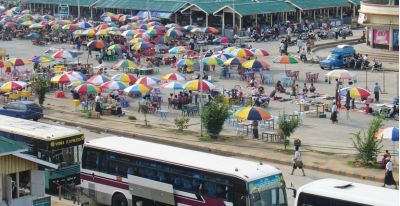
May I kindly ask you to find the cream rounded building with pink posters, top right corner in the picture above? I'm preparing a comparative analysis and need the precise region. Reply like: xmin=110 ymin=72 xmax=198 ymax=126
xmin=358 ymin=0 xmax=399 ymax=51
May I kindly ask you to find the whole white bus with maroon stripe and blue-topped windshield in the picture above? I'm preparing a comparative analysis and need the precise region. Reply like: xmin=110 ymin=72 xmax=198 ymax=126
xmin=81 ymin=136 xmax=287 ymax=206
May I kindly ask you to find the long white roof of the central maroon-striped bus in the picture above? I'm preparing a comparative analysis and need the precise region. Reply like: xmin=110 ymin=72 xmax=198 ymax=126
xmin=85 ymin=136 xmax=281 ymax=181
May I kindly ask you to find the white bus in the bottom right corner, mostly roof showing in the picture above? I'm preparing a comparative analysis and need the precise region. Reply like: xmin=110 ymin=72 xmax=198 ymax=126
xmin=295 ymin=179 xmax=399 ymax=206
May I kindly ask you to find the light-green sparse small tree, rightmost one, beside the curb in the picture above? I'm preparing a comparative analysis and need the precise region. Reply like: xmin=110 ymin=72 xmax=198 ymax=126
xmin=352 ymin=117 xmax=383 ymax=166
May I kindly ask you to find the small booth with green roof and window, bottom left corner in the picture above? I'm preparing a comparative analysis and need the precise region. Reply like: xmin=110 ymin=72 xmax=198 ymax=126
xmin=0 ymin=137 xmax=51 ymax=206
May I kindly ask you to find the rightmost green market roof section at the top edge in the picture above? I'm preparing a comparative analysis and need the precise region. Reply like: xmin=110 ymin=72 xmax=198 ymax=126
xmin=287 ymin=0 xmax=350 ymax=10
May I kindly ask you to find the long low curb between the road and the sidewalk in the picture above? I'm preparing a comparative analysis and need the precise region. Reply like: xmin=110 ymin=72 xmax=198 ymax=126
xmin=43 ymin=116 xmax=384 ymax=182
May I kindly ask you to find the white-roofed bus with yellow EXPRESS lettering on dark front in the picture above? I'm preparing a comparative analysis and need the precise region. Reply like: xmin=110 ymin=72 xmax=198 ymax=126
xmin=0 ymin=115 xmax=85 ymax=193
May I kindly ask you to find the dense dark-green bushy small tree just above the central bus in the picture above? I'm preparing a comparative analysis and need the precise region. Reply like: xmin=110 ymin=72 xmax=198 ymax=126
xmin=201 ymin=102 xmax=229 ymax=139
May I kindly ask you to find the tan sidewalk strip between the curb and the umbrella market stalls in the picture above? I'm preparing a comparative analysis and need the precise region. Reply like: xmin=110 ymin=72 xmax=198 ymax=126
xmin=41 ymin=97 xmax=398 ymax=182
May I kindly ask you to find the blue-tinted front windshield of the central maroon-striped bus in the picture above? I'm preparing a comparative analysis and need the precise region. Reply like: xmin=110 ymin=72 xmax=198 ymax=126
xmin=248 ymin=174 xmax=287 ymax=206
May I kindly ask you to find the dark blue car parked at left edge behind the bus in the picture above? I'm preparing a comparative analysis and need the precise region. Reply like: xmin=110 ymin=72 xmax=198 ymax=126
xmin=0 ymin=101 xmax=43 ymax=121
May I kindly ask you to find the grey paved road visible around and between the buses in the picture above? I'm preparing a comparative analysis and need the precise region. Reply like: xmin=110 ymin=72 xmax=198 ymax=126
xmin=40 ymin=120 xmax=383 ymax=205
